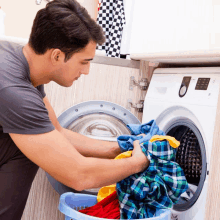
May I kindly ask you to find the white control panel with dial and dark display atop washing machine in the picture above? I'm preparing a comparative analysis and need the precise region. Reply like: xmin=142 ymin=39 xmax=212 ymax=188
xmin=151 ymin=67 xmax=220 ymax=107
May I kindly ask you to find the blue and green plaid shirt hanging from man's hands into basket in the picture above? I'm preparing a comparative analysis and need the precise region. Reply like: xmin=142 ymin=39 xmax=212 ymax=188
xmin=116 ymin=121 xmax=188 ymax=219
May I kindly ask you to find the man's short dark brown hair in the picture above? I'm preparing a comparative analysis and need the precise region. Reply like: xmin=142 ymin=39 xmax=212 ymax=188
xmin=29 ymin=0 xmax=105 ymax=62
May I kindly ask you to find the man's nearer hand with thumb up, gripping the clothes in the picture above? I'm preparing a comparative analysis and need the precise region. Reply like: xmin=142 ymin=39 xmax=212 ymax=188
xmin=132 ymin=140 xmax=150 ymax=172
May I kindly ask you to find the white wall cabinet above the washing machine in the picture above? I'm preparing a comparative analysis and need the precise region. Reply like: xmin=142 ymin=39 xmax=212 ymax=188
xmin=120 ymin=0 xmax=220 ymax=61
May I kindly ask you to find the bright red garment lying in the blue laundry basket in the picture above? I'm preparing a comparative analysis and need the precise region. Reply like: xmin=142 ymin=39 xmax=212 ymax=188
xmin=79 ymin=191 xmax=120 ymax=219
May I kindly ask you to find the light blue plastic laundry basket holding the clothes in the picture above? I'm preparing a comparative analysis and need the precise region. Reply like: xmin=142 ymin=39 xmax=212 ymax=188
xmin=59 ymin=192 xmax=171 ymax=220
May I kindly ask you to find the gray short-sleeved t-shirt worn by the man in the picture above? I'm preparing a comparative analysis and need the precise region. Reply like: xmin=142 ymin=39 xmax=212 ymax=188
xmin=0 ymin=41 xmax=55 ymax=137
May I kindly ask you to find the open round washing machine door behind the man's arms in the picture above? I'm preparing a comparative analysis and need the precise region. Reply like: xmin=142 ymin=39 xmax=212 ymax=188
xmin=46 ymin=101 xmax=141 ymax=195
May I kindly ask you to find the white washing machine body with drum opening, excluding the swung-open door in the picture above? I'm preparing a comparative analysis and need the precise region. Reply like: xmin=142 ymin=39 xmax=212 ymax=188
xmin=142 ymin=67 xmax=220 ymax=220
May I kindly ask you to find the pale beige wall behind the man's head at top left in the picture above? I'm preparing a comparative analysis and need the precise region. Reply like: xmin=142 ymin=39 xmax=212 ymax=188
xmin=0 ymin=0 xmax=98 ymax=38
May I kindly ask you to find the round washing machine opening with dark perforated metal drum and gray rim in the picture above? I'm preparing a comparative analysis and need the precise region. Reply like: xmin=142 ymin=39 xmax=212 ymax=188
xmin=165 ymin=119 xmax=207 ymax=211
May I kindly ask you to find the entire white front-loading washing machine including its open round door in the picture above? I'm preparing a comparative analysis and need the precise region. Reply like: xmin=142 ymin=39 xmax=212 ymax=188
xmin=47 ymin=67 xmax=220 ymax=220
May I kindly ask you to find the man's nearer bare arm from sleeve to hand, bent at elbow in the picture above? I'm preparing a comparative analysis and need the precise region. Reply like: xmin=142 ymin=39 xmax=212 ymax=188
xmin=10 ymin=129 xmax=149 ymax=191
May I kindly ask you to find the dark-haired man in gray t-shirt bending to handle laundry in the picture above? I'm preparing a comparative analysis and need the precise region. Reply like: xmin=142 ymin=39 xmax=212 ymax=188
xmin=0 ymin=0 xmax=149 ymax=220
